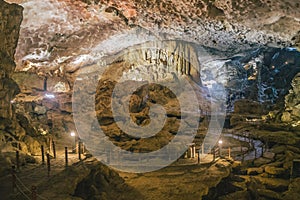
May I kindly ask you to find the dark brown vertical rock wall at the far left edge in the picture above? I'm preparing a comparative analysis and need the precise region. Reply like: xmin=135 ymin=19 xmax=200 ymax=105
xmin=0 ymin=0 xmax=23 ymax=130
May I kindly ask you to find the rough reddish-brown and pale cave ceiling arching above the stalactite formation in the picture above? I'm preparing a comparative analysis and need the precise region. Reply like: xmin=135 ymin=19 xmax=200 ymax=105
xmin=2 ymin=0 xmax=300 ymax=76
